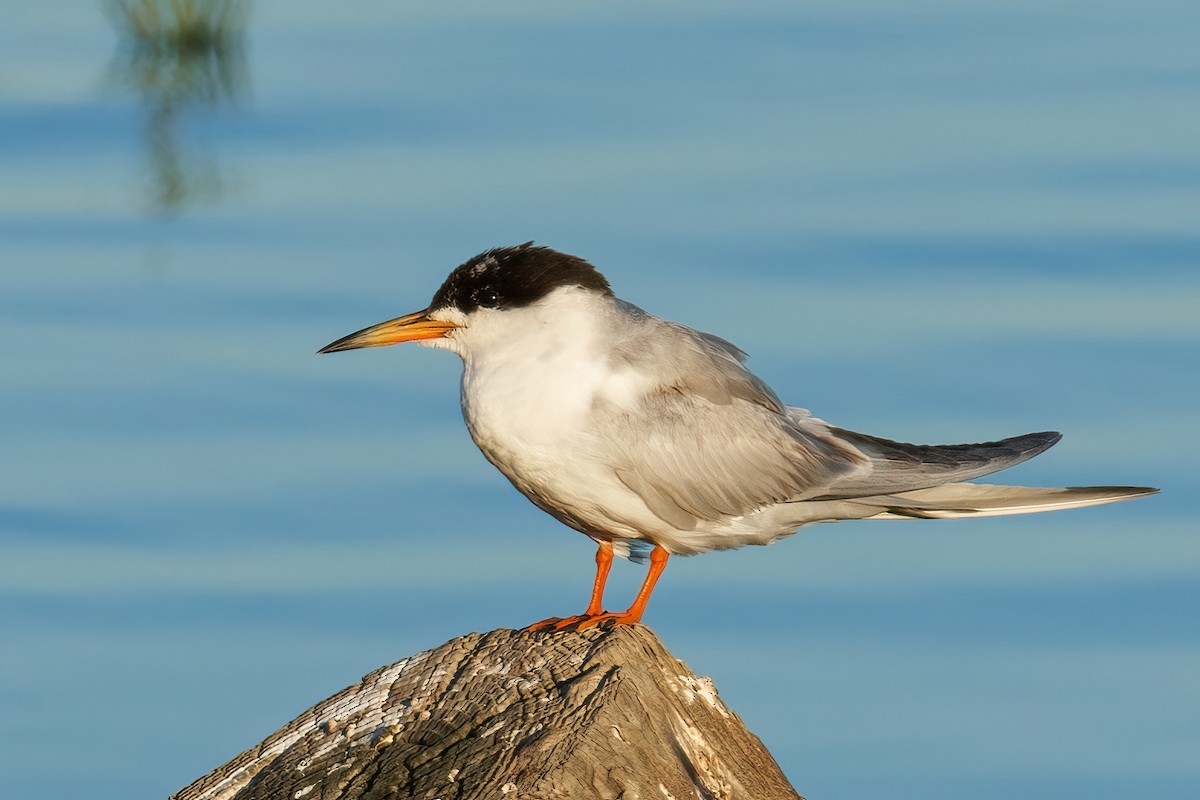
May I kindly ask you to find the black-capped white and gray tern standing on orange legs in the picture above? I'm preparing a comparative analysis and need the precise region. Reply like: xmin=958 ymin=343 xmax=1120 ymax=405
xmin=320 ymin=242 xmax=1157 ymax=628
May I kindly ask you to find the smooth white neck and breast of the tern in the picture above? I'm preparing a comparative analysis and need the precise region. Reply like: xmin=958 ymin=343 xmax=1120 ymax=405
xmin=455 ymin=290 xmax=660 ymax=539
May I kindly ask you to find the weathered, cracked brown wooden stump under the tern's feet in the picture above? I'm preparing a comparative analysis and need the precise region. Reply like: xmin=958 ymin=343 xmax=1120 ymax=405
xmin=172 ymin=626 xmax=799 ymax=800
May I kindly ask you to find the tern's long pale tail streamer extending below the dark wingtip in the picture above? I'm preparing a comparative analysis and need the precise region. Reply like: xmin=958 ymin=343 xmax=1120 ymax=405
xmin=853 ymin=483 xmax=1158 ymax=519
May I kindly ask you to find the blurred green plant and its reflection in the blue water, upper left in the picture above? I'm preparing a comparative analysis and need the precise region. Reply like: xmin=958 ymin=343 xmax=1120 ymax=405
xmin=103 ymin=0 xmax=250 ymax=215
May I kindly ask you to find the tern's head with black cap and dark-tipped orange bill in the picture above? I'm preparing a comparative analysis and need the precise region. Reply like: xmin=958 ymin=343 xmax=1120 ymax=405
xmin=319 ymin=242 xmax=612 ymax=355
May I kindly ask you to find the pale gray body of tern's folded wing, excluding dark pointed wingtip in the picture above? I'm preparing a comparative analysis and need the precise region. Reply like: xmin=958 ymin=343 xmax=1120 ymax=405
xmin=596 ymin=309 xmax=870 ymax=530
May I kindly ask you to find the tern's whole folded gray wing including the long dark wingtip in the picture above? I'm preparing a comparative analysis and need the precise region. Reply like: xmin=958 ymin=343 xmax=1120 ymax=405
xmin=596 ymin=306 xmax=1060 ymax=530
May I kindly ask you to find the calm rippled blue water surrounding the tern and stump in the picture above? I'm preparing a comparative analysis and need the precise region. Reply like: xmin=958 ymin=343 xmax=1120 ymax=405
xmin=0 ymin=0 xmax=1200 ymax=799
